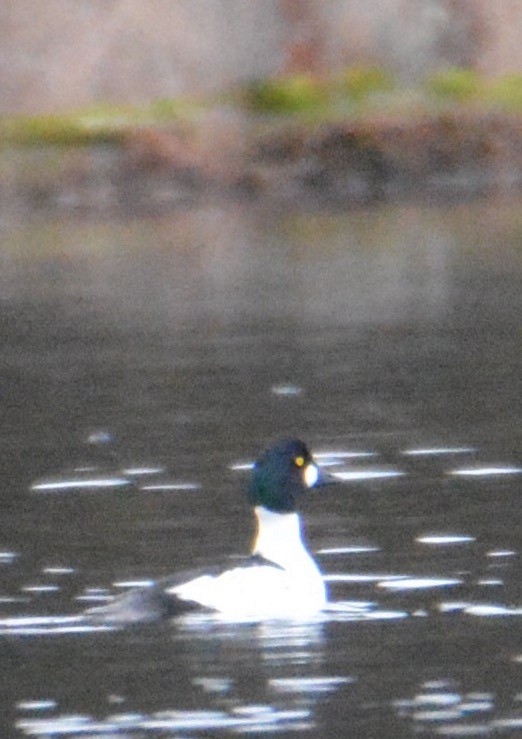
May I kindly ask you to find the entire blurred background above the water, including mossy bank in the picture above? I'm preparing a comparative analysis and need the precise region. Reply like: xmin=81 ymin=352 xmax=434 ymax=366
xmin=0 ymin=0 xmax=522 ymax=218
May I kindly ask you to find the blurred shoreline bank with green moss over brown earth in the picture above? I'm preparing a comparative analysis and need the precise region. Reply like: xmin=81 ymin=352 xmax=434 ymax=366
xmin=0 ymin=71 xmax=522 ymax=221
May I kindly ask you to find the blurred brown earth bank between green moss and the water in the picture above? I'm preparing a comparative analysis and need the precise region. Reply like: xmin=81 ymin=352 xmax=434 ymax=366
xmin=0 ymin=111 xmax=522 ymax=219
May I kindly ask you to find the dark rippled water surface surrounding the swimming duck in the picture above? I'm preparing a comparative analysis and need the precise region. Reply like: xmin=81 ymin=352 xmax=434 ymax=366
xmin=0 ymin=200 xmax=522 ymax=739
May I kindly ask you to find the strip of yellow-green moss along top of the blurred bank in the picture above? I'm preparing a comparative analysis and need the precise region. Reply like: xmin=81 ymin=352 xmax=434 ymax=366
xmin=0 ymin=67 xmax=522 ymax=145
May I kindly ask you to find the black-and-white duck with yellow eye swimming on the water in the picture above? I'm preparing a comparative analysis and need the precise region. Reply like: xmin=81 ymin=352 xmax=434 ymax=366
xmin=86 ymin=438 xmax=338 ymax=624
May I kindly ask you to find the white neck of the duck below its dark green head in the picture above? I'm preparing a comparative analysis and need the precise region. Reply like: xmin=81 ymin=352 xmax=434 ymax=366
xmin=253 ymin=506 xmax=316 ymax=569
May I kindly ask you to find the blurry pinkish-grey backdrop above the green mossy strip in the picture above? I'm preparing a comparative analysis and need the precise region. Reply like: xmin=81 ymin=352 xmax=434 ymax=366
xmin=0 ymin=0 xmax=522 ymax=113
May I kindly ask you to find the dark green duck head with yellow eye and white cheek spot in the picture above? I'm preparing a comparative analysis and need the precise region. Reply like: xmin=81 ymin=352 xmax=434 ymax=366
xmin=248 ymin=439 xmax=326 ymax=513
